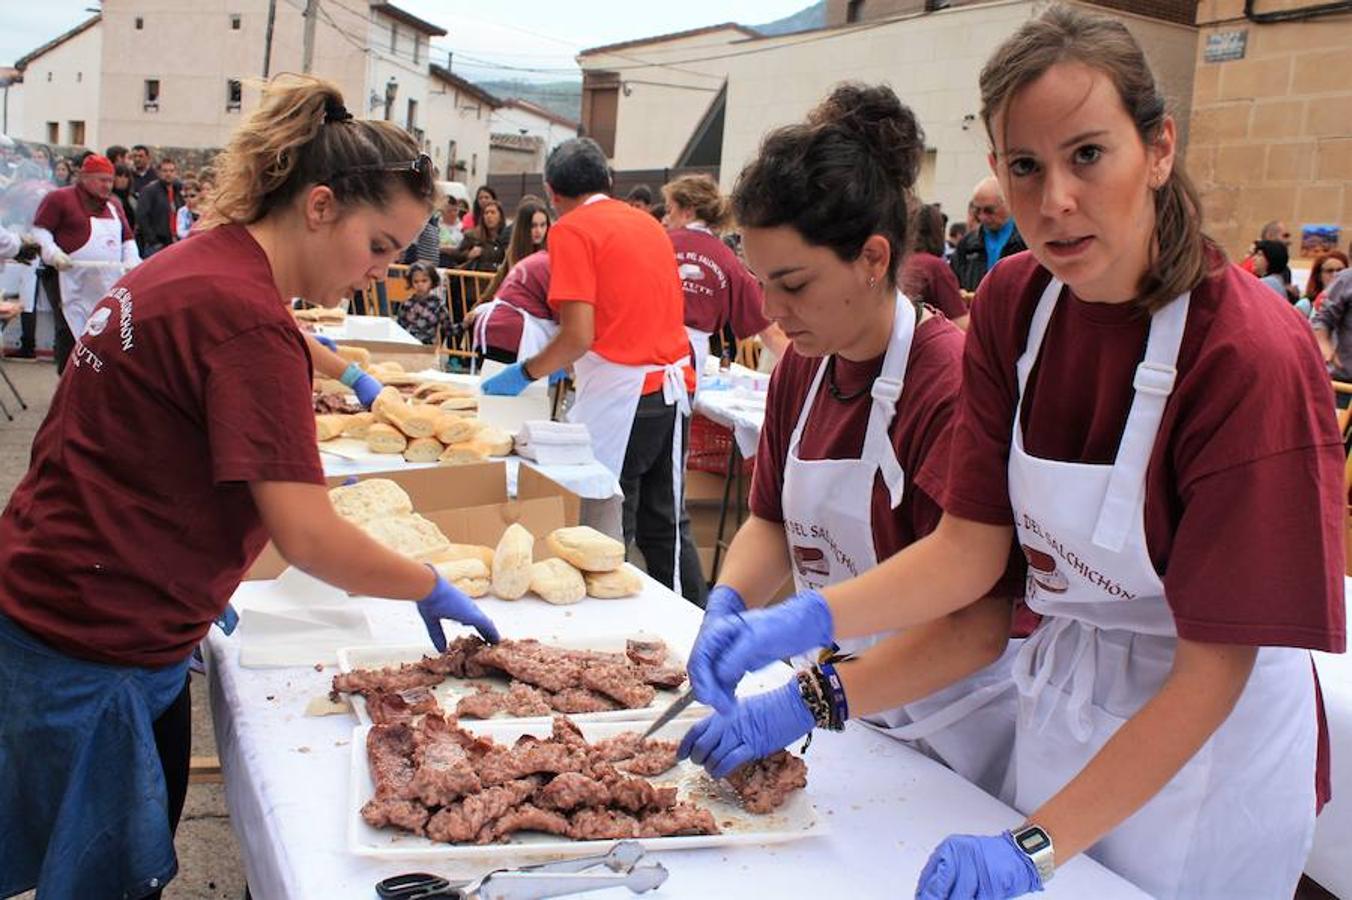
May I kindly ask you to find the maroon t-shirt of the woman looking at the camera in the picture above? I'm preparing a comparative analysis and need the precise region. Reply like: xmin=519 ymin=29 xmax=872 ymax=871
xmin=922 ymin=253 xmax=1347 ymax=805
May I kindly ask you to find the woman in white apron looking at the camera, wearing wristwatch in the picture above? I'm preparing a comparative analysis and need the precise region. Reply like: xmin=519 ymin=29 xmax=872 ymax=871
xmin=691 ymin=7 xmax=1345 ymax=900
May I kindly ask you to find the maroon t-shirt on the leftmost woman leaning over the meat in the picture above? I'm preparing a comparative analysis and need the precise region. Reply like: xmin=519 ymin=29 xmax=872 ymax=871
xmin=0 ymin=226 xmax=323 ymax=666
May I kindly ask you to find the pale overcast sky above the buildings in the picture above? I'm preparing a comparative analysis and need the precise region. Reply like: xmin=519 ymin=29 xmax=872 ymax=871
xmin=0 ymin=0 xmax=811 ymax=80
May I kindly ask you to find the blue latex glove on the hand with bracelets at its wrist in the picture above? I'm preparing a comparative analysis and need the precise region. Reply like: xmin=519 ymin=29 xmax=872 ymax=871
xmin=676 ymin=678 xmax=817 ymax=778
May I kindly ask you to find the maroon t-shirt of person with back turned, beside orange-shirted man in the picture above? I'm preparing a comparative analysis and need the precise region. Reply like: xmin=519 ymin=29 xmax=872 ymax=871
xmin=668 ymin=228 xmax=769 ymax=341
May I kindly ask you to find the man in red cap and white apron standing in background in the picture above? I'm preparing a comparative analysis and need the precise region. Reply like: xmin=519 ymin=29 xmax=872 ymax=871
xmin=32 ymin=153 xmax=141 ymax=372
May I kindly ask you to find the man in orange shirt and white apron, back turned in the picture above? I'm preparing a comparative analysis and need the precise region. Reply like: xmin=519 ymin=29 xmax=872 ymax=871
xmin=483 ymin=138 xmax=706 ymax=605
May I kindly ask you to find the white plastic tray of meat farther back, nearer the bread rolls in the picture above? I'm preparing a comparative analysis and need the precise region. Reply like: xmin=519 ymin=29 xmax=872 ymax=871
xmin=338 ymin=631 xmax=784 ymax=724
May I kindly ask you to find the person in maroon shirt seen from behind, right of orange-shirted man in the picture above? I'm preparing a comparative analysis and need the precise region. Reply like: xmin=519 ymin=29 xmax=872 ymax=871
xmin=662 ymin=174 xmax=788 ymax=377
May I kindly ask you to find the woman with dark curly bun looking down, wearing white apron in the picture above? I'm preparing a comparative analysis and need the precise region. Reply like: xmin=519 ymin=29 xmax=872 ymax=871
xmin=681 ymin=86 xmax=1022 ymax=793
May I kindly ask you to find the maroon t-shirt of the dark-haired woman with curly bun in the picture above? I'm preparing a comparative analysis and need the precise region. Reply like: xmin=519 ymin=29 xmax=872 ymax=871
xmin=750 ymin=316 xmax=1023 ymax=597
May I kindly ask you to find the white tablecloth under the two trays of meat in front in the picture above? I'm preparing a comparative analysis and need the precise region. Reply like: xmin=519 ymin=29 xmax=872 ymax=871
xmin=207 ymin=570 xmax=1145 ymax=900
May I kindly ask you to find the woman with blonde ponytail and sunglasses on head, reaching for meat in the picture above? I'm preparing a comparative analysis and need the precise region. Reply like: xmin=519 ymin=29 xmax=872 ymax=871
xmin=0 ymin=78 xmax=496 ymax=900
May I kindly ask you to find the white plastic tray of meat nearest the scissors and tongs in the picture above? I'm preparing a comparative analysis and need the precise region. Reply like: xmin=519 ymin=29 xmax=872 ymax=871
xmin=347 ymin=716 xmax=826 ymax=861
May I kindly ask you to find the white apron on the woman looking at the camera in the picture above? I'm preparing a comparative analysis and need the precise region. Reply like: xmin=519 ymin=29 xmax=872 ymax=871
xmin=1005 ymin=280 xmax=1317 ymax=900
